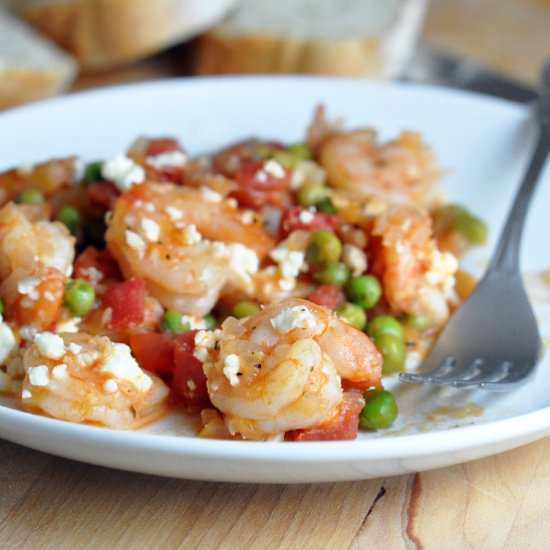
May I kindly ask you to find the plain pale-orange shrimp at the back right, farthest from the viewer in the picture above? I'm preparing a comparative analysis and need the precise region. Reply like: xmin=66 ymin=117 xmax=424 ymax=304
xmin=316 ymin=109 xmax=439 ymax=204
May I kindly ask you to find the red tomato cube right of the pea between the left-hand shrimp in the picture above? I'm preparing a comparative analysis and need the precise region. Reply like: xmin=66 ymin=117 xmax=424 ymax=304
xmin=103 ymin=277 xmax=145 ymax=330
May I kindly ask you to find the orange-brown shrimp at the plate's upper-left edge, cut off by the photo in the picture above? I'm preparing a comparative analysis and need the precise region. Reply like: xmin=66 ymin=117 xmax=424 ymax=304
xmin=0 ymin=157 xmax=84 ymax=206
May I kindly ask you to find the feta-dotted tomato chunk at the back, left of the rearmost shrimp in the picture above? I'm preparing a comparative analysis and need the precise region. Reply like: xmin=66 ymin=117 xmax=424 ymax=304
xmin=231 ymin=159 xmax=290 ymax=212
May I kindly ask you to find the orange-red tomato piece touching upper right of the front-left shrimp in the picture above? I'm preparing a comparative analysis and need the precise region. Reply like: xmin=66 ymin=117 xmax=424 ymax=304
xmin=130 ymin=332 xmax=174 ymax=376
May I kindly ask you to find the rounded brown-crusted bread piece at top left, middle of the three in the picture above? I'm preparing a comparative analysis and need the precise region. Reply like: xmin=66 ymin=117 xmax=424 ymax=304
xmin=14 ymin=0 xmax=236 ymax=70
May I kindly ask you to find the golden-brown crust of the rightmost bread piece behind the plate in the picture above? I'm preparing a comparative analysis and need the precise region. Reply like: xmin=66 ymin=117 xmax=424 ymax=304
xmin=194 ymin=28 xmax=381 ymax=76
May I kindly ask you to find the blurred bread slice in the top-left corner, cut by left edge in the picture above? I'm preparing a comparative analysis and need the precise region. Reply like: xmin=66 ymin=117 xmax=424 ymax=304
xmin=0 ymin=10 xmax=77 ymax=109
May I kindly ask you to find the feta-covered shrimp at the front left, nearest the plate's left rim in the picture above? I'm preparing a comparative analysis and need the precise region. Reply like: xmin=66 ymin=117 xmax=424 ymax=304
xmin=21 ymin=332 xmax=169 ymax=429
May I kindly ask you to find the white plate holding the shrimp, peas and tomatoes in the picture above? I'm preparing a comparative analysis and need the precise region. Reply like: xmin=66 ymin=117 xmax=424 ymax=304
xmin=0 ymin=77 xmax=550 ymax=483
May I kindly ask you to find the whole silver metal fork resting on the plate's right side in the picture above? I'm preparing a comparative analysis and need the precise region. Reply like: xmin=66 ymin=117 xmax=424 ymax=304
xmin=399 ymin=62 xmax=550 ymax=391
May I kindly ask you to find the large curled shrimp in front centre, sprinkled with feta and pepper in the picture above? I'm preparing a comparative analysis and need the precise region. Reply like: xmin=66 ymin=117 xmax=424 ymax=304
xmin=195 ymin=298 xmax=382 ymax=440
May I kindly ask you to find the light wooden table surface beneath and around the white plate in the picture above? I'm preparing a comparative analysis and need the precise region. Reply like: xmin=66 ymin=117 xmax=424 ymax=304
xmin=0 ymin=0 xmax=550 ymax=550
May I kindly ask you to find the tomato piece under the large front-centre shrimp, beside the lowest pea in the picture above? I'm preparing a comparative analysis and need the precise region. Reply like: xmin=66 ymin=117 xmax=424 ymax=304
xmin=285 ymin=393 xmax=365 ymax=441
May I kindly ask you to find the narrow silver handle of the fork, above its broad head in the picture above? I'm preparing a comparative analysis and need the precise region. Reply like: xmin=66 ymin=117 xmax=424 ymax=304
xmin=487 ymin=113 xmax=550 ymax=275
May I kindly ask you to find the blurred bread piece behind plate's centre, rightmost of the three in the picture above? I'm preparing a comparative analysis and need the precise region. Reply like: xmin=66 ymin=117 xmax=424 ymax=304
xmin=194 ymin=0 xmax=427 ymax=77
